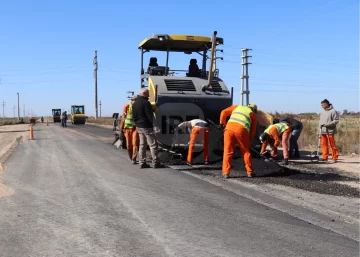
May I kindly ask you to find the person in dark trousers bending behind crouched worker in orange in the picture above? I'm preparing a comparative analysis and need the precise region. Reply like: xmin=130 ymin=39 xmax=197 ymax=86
xmin=274 ymin=117 xmax=303 ymax=159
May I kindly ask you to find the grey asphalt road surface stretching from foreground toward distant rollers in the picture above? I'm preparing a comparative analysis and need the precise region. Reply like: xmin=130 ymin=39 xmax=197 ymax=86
xmin=0 ymin=124 xmax=359 ymax=257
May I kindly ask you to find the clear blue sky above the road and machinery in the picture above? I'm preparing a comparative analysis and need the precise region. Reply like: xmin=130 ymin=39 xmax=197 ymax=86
xmin=0 ymin=0 xmax=359 ymax=116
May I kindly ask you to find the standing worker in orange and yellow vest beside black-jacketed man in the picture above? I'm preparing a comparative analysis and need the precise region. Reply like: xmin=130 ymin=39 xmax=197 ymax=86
xmin=119 ymin=95 xmax=139 ymax=164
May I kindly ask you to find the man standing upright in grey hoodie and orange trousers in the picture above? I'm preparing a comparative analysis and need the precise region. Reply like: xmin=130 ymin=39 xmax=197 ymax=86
xmin=319 ymin=99 xmax=339 ymax=163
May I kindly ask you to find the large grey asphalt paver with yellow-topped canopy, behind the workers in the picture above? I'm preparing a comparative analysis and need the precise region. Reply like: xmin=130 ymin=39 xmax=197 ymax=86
xmin=138 ymin=31 xmax=233 ymax=157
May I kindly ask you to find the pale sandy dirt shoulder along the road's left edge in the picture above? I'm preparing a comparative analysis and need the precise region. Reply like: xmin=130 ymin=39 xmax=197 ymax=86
xmin=0 ymin=124 xmax=29 ymax=197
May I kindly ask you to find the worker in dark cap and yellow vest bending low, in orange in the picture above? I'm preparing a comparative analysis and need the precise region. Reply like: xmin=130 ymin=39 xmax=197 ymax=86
xmin=260 ymin=122 xmax=291 ymax=165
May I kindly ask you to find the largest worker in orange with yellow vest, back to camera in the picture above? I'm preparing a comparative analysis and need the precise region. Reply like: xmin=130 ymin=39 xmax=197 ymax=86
xmin=220 ymin=104 xmax=257 ymax=178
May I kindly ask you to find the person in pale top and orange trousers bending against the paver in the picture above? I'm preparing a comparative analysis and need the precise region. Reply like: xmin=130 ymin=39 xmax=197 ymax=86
xmin=177 ymin=119 xmax=210 ymax=165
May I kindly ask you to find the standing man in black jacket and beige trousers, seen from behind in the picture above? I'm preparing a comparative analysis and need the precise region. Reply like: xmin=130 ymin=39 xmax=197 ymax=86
xmin=132 ymin=89 xmax=163 ymax=169
